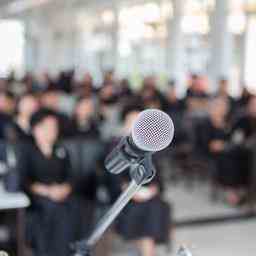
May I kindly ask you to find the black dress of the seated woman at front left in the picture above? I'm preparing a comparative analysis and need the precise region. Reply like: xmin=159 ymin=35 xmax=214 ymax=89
xmin=19 ymin=145 xmax=82 ymax=256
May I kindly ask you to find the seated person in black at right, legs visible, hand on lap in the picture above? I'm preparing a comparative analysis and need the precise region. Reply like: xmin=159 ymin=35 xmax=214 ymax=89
xmin=198 ymin=98 xmax=248 ymax=205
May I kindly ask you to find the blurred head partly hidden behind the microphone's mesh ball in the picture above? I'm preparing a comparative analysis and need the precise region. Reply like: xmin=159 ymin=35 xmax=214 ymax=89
xmin=121 ymin=103 xmax=143 ymax=134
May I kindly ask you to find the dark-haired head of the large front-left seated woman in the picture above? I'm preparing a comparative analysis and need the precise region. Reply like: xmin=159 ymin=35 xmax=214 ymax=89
xmin=30 ymin=109 xmax=59 ymax=145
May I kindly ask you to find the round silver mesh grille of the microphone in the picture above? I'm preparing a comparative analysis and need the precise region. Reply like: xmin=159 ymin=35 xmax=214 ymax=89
xmin=132 ymin=109 xmax=174 ymax=152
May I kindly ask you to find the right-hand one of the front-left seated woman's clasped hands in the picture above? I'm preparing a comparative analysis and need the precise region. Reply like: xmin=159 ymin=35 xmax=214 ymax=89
xmin=49 ymin=184 xmax=72 ymax=202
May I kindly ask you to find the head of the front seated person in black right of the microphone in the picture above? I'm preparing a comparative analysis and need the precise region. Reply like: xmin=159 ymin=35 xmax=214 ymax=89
xmin=209 ymin=97 xmax=229 ymax=121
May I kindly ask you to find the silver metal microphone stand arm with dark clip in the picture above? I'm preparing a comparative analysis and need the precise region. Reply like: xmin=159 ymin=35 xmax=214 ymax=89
xmin=72 ymin=154 xmax=156 ymax=256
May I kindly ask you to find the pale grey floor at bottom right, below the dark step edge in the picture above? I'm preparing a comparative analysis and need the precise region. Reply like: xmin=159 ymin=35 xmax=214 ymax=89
xmin=173 ymin=219 xmax=256 ymax=256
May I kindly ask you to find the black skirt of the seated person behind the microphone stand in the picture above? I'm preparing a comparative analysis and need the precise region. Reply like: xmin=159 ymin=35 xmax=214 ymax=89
xmin=117 ymin=170 xmax=171 ymax=244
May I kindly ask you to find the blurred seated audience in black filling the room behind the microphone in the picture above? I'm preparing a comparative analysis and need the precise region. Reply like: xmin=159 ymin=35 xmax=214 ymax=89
xmin=0 ymin=71 xmax=256 ymax=256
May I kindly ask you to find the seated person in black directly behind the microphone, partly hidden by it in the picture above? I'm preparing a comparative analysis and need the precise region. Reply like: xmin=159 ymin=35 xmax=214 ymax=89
xmin=117 ymin=106 xmax=171 ymax=256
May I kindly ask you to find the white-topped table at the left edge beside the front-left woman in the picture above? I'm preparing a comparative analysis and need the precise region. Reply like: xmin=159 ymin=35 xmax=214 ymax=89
xmin=0 ymin=189 xmax=30 ymax=256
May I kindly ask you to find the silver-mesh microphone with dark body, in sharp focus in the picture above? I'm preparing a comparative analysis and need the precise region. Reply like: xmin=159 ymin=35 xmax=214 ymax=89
xmin=105 ymin=109 xmax=174 ymax=174
